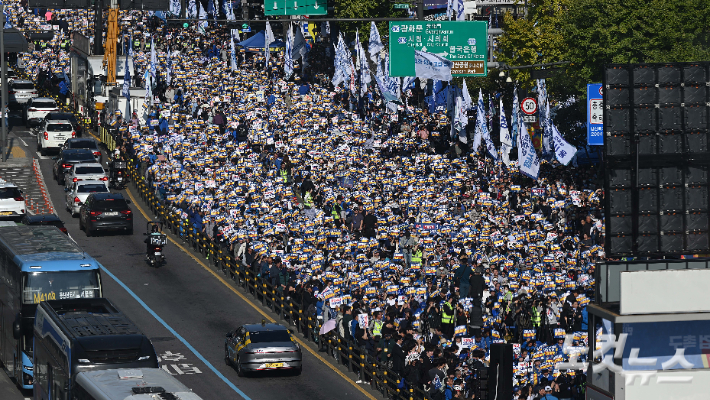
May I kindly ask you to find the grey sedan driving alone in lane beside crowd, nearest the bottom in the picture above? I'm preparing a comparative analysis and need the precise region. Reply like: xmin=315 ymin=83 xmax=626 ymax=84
xmin=224 ymin=323 xmax=303 ymax=376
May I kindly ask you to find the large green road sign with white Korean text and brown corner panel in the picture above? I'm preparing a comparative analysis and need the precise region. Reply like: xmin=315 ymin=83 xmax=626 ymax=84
xmin=389 ymin=21 xmax=488 ymax=76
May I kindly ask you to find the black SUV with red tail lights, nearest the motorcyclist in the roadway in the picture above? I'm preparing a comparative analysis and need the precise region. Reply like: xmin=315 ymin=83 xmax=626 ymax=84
xmin=79 ymin=193 xmax=133 ymax=236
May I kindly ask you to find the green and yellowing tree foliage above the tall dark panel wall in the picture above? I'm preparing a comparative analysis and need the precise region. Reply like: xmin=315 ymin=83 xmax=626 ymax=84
xmin=498 ymin=0 xmax=710 ymax=145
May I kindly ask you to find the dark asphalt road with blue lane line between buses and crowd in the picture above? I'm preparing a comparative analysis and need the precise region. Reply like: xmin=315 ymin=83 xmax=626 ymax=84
xmin=12 ymin=122 xmax=373 ymax=400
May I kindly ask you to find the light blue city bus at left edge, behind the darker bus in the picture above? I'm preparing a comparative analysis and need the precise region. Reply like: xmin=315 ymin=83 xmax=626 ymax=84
xmin=0 ymin=225 xmax=103 ymax=389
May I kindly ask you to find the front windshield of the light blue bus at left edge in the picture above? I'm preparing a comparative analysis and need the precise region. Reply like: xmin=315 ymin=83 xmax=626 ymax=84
xmin=22 ymin=270 xmax=101 ymax=304
